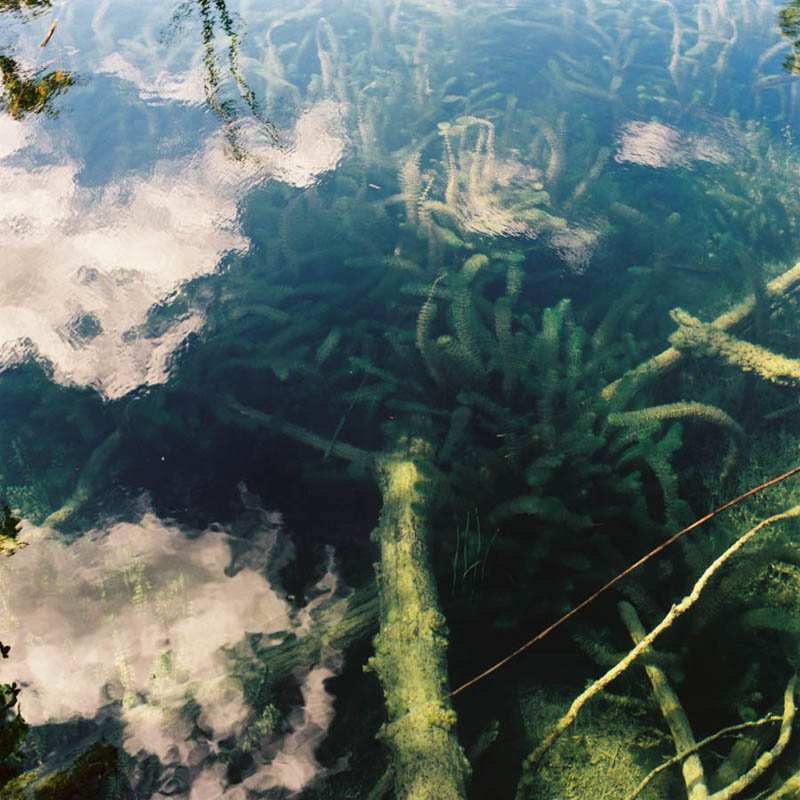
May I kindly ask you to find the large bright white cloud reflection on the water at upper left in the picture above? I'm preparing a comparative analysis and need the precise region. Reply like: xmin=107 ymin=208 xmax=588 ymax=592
xmin=0 ymin=124 xmax=248 ymax=398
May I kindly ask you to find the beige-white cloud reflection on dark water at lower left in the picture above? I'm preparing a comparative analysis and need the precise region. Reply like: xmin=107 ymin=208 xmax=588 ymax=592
xmin=0 ymin=496 xmax=342 ymax=800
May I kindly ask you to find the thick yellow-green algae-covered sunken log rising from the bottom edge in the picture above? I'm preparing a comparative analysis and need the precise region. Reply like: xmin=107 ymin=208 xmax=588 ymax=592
xmin=369 ymin=441 xmax=470 ymax=800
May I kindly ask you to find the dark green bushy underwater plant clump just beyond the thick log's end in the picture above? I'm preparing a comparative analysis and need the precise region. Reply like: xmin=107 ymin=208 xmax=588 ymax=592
xmin=338 ymin=260 xmax=742 ymax=616
